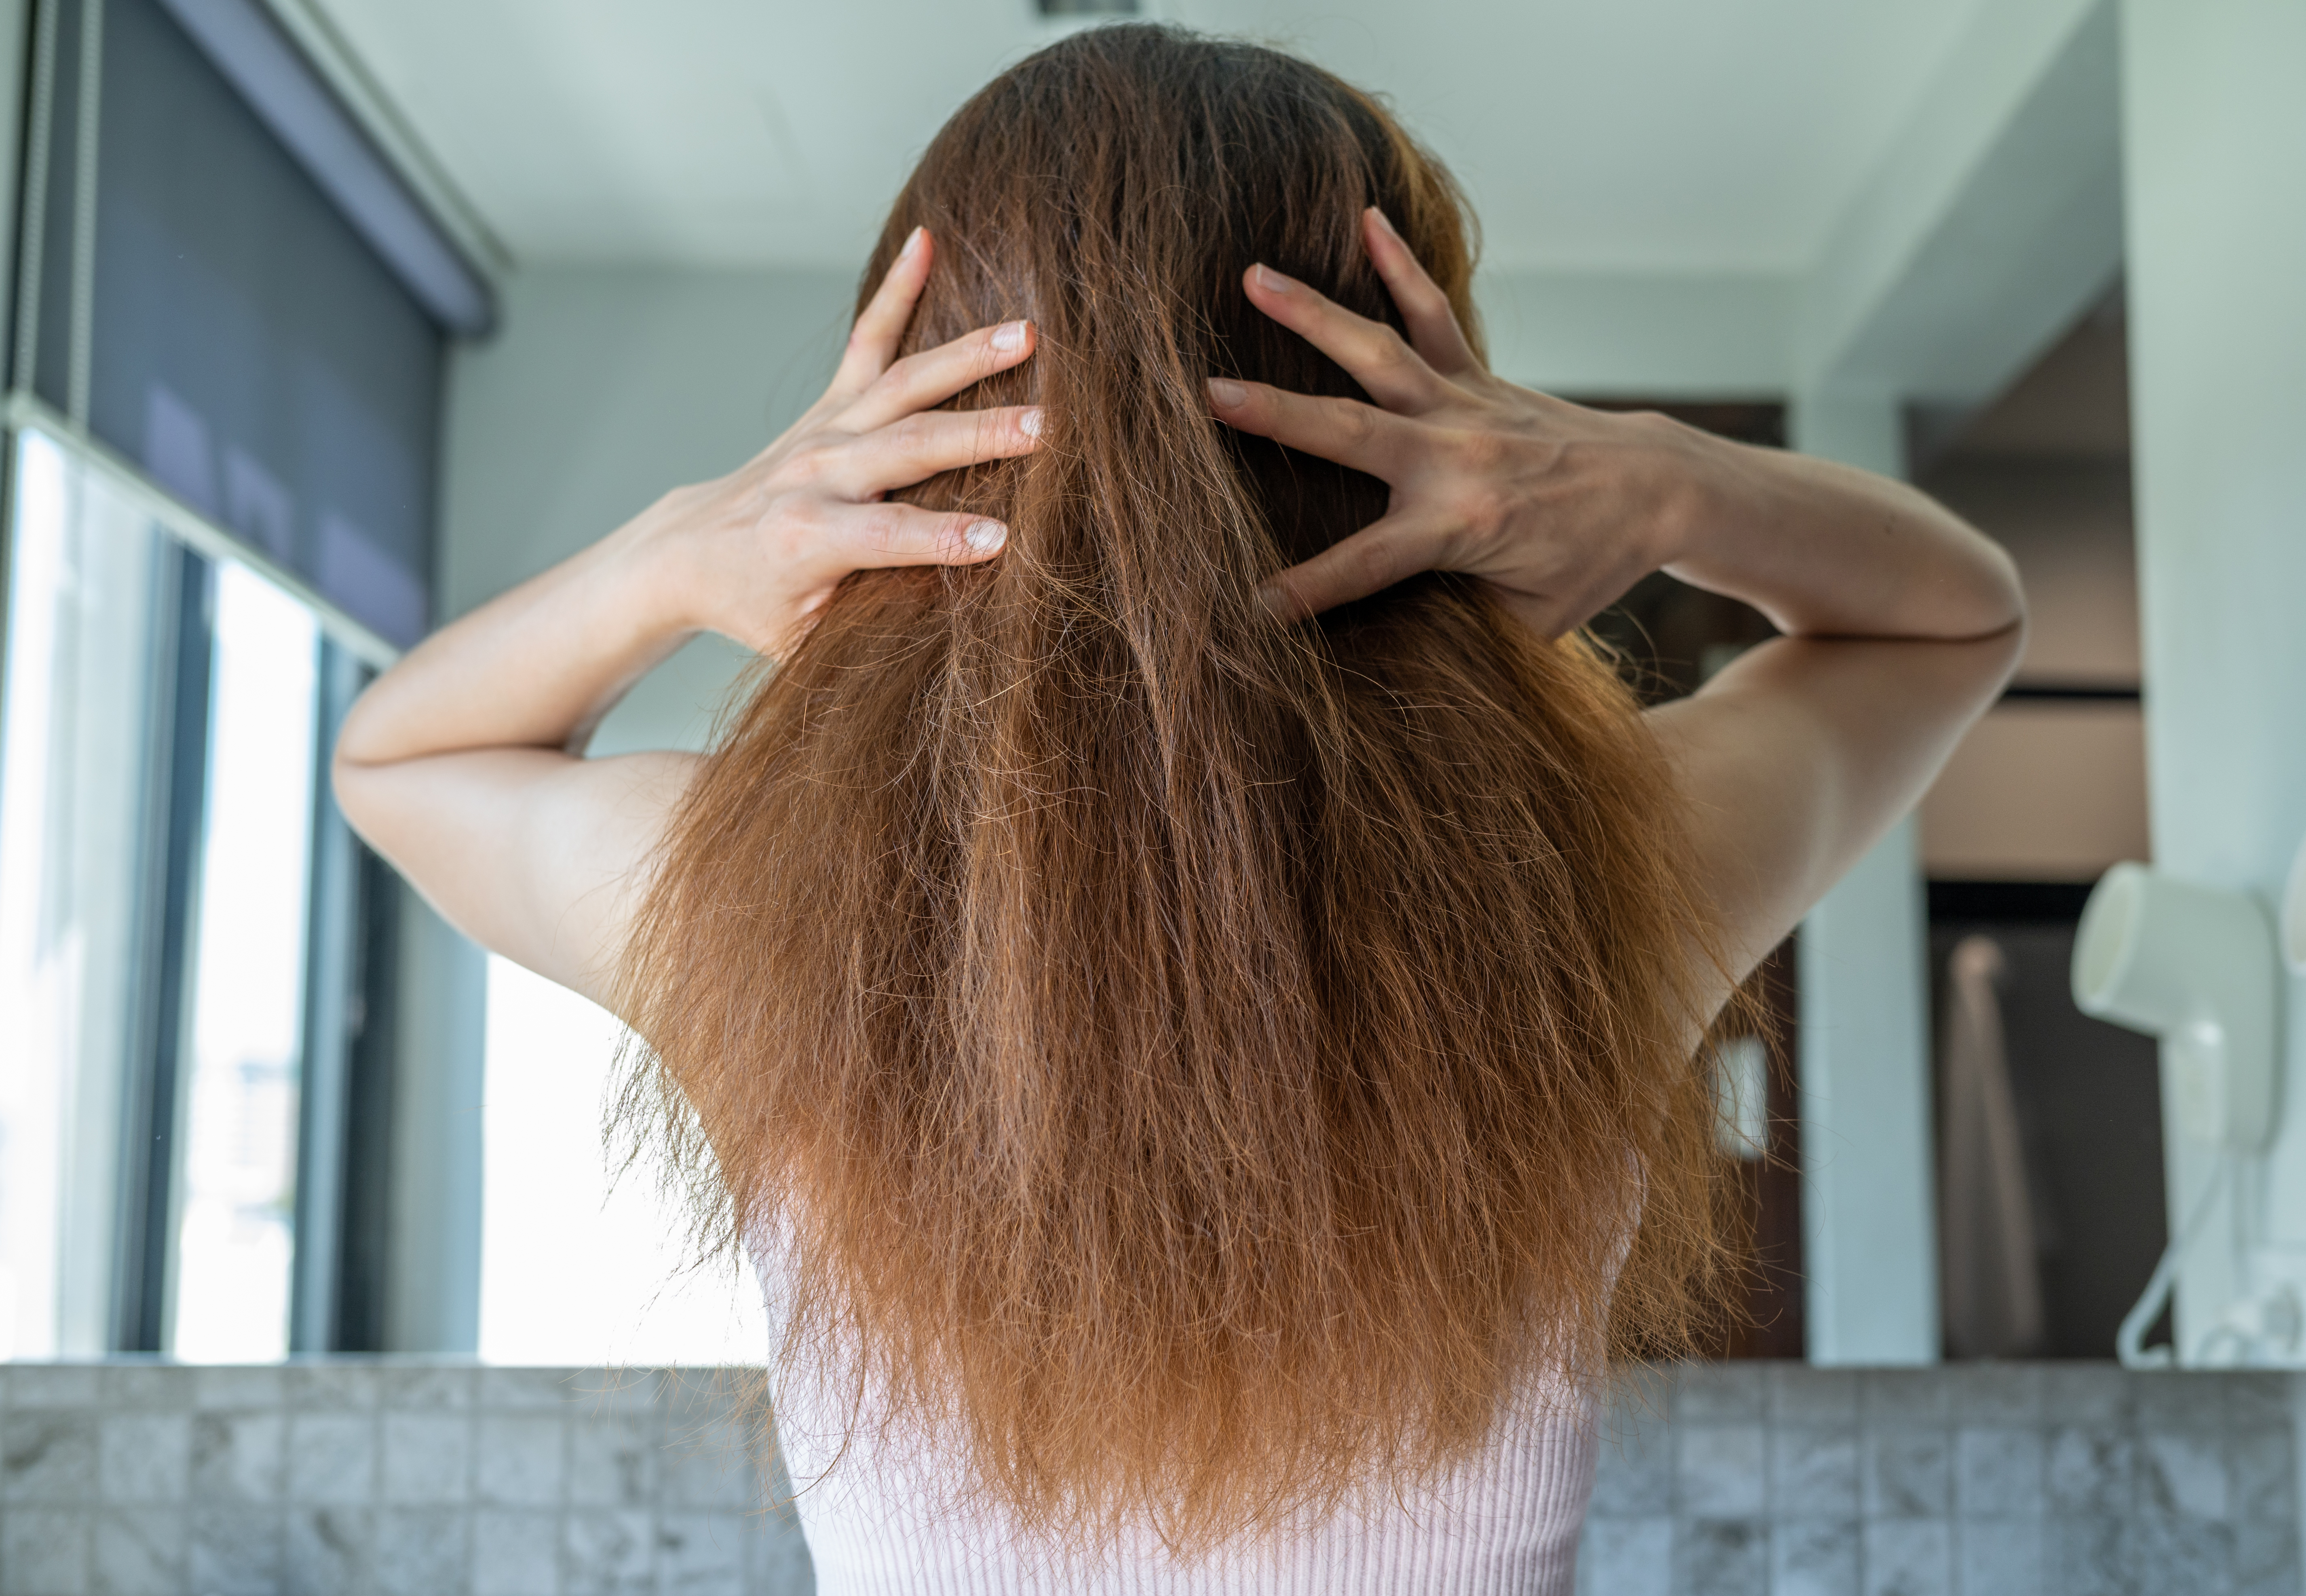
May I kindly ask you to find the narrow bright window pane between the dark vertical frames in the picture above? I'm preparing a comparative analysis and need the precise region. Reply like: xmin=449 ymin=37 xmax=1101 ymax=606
xmin=173 ymin=563 xmax=321 ymax=1363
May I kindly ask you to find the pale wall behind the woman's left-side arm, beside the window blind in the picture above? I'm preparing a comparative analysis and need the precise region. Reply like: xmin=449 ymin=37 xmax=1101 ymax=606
xmin=387 ymin=270 xmax=851 ymax=1356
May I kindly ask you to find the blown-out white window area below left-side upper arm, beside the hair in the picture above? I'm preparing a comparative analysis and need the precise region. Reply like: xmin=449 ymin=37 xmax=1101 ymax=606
xmin=479 ymin=957 xmax=768 ymax=1365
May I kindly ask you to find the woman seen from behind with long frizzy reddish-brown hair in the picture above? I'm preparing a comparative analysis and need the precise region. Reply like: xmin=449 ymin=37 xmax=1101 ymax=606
xmin=337 ymin=27 xmax=2022 ymax=1592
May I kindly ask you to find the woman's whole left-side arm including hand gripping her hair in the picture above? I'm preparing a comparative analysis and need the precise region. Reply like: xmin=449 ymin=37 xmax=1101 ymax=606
xmin=334 ymin=233 xmax=1038 ymax=1001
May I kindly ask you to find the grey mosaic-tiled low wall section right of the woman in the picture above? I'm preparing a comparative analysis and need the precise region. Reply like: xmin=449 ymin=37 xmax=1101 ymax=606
xmin=1577 ymin=1363 xmax=2299 ymax=1596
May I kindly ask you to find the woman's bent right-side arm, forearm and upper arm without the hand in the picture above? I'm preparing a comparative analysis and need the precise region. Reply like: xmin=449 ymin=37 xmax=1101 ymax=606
xmin=1649 ymin=440 xmax=2025 ymax=973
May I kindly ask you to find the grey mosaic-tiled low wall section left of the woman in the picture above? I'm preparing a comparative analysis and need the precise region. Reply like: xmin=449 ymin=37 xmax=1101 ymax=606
xmin=0 ymin=1361 xmax=812 ymax=1596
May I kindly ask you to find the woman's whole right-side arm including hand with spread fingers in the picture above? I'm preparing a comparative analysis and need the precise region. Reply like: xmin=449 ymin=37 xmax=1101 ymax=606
xmin=1211 ymin=210 xmax=2025 ymax=996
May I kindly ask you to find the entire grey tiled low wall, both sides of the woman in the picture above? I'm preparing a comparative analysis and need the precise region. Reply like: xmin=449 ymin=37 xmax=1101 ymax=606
xmin=0 ymin=1361 xmax=2302 ymax=1596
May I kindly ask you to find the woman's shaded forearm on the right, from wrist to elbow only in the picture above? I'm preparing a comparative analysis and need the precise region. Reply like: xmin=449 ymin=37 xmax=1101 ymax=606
xmin=1663 ymin=422 xmax=2025 ymax=639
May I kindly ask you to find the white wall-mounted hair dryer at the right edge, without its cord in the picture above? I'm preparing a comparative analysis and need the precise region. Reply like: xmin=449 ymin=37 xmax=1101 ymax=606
xmin=2073 ymin=863 xmax=2297 ymax=1153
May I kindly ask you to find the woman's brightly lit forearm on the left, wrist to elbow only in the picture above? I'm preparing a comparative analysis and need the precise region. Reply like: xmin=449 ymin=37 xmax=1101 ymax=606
xmin=337 ymin=514 xmax=694 ymax=775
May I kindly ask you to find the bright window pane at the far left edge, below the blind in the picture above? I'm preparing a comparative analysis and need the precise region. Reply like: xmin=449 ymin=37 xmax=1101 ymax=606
xmin=0 ymin=429 xmax=164 ymax=1358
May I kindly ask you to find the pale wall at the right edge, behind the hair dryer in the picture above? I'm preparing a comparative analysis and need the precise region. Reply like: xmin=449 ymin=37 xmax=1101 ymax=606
xmin=2122 ymin=0 xmax=2306 ymax=1356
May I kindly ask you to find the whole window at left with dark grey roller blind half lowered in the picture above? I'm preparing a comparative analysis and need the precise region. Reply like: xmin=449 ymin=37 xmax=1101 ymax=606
xmin=0 ymin=0 xmax=489 ymax=1361
